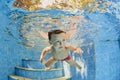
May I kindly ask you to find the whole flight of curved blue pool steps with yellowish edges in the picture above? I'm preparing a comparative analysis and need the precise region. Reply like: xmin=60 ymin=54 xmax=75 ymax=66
xmin=8 ymin=58 xmax=71 ymax=80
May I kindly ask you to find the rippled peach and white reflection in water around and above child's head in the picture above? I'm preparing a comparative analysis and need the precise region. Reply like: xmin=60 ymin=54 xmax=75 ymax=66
xmin=8 ymin=1 xmax=120 ymax=50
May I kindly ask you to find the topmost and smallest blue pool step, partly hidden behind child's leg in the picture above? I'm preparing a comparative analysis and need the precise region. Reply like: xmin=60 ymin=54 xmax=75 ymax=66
xmin=22 ymin=58 xmax=62 ymax=69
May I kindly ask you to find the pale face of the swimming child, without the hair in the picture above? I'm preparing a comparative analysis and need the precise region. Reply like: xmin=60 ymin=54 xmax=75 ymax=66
xmin=50 ymin=33 xmax=66 ymax=50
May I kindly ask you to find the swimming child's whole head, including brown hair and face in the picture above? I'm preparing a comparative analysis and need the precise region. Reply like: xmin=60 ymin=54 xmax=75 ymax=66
xmin=48 ymin=30 xmax=66 ymax=48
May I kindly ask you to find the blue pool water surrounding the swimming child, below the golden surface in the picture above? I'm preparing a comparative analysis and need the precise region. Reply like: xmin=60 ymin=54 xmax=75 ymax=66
xmin=0 ymin=0 xmax=120 ymax=80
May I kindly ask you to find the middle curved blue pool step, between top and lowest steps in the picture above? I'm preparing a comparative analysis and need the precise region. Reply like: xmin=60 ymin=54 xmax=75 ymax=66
xmin=15 ymin=66 xmax=63 ymax=79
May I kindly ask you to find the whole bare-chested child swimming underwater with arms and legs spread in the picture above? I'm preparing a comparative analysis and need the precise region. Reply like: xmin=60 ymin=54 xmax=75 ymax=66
xmin=40 ymin=30 xmax=83 ymax=70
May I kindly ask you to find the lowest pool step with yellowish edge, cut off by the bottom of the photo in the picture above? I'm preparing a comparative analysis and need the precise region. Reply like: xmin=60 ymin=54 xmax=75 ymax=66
xmin=8 ymin=75 xmax=71 ymax=80
